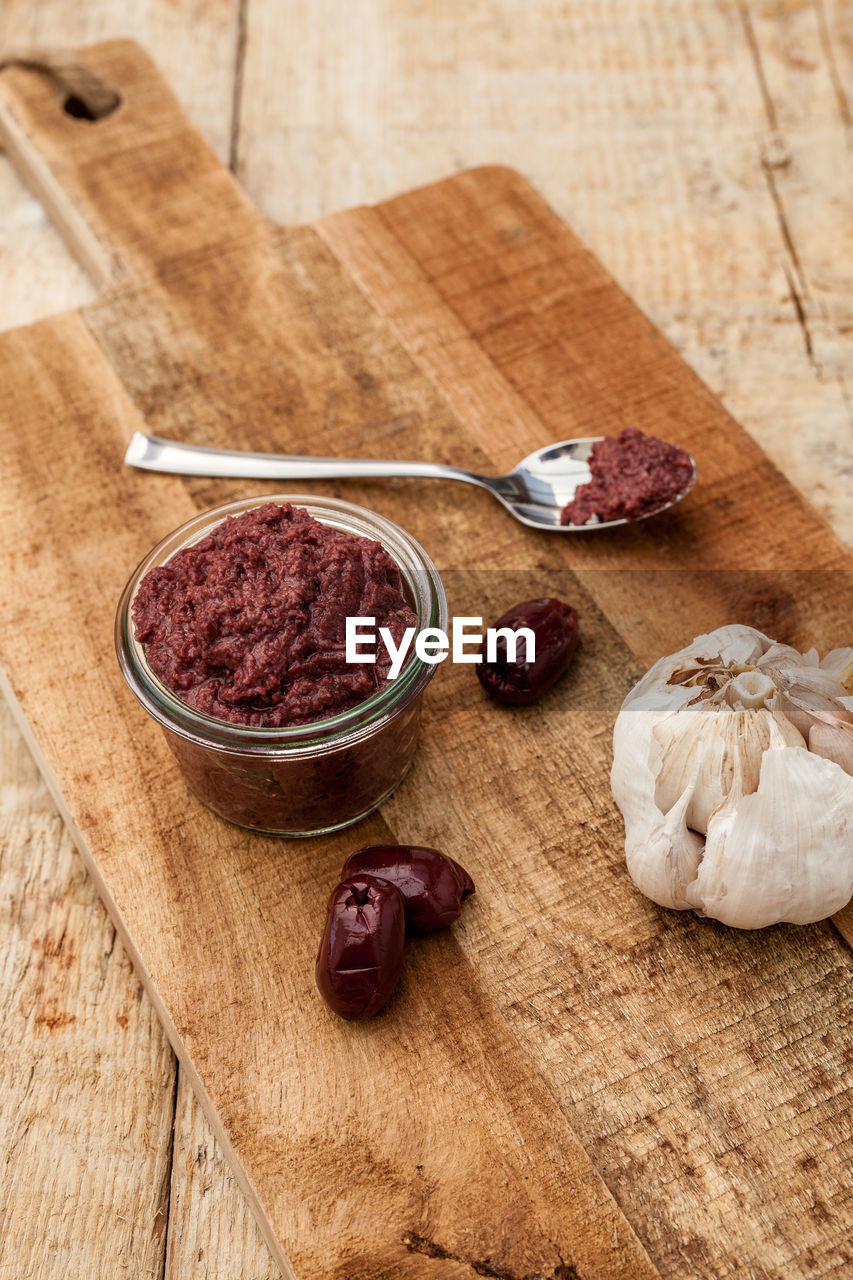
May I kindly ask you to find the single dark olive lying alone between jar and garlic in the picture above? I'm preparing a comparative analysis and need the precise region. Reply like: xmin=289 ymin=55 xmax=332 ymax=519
xmin=476 ymin=595 xmax=578 ymax=707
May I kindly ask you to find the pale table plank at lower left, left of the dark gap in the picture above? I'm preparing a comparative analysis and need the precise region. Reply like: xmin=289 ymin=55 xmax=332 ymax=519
xmin=0 ymin=701 xmax=173 ymax=1280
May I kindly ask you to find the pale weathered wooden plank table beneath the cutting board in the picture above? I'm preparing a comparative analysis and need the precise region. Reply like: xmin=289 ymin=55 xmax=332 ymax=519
xmin=0 ymin=0 xmax=853 ymax=1280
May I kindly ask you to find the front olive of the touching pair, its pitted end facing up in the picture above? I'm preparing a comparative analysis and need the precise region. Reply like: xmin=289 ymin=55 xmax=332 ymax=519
xmin=315 ymin=876 xmax=406 ymax=1020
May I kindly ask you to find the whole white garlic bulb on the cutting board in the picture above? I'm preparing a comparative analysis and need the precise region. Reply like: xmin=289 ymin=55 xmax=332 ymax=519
xmin=611 ymin=626 xmax=853 ymax=929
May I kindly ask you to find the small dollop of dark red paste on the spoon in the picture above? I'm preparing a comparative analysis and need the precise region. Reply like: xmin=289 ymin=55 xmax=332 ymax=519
xmin=560 ymin=426 xmax=693 ymax=525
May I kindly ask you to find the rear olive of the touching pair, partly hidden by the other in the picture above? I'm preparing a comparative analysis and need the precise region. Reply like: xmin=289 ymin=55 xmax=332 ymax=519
xmin=343 ymin=845 xmax=474 ymax=933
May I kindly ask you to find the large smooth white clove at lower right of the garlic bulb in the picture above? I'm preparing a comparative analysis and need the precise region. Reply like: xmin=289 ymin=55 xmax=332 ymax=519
xmin=685 ymin=746 xmax=853 ymax=929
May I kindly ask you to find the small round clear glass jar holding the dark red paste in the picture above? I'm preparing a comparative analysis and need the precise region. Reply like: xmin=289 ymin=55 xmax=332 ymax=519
xmin=115 ymin=494 xmax=447 ymax=836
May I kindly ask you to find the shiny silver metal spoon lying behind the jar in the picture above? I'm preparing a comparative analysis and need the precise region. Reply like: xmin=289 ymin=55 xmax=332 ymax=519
xmin=124 ymin=431 xmax=695 ymax=534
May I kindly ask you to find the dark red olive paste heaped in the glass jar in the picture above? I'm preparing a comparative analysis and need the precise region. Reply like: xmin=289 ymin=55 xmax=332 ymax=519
xmin=133 ymin=503 xmax=416 ymax=727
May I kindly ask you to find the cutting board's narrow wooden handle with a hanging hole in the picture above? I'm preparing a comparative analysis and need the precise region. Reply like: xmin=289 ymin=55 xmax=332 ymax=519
xmin=0 ymin=40 xmax=266 ymax=289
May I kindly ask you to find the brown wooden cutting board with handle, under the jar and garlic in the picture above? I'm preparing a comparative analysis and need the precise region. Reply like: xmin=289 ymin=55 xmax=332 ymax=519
xmin=0 ymin=42 xmax=853 ymax=1280
